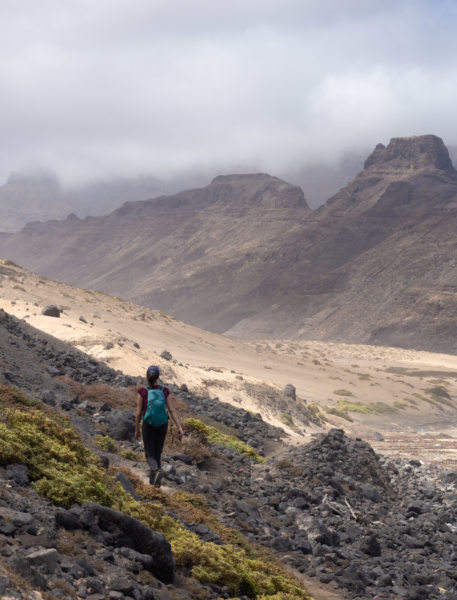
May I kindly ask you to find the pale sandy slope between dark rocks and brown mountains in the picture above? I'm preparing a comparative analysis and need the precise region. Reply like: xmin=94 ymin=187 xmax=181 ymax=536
xmin=0 ymin=260 xmax=457 ymax=452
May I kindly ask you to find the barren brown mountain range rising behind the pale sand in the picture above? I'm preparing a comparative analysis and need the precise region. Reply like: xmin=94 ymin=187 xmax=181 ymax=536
xmin=0 ymin=135 xmax=457 ymax=353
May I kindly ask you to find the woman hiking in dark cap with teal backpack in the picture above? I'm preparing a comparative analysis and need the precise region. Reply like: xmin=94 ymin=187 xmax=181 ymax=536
xmin=135 ymin=365 xmax=184 ymax=487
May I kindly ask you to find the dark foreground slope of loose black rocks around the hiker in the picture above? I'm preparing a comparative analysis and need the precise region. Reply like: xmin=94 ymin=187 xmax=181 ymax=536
xmin=0 ymin=312 xmax=457 ymax=600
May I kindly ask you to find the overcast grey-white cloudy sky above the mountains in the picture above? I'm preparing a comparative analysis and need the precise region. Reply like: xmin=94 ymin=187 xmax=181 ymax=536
xmin=0 ymin=0 xmax=457 ymax=182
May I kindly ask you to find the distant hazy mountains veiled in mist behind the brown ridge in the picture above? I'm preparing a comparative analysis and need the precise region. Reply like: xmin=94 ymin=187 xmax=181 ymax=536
xmin=0 ymin=152 xmax=365 ymax=234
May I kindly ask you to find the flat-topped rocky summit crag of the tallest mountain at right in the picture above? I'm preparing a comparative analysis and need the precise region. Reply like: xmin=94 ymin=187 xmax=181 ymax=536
xmin=364 ymin=135 xmax=457 ymax=174
